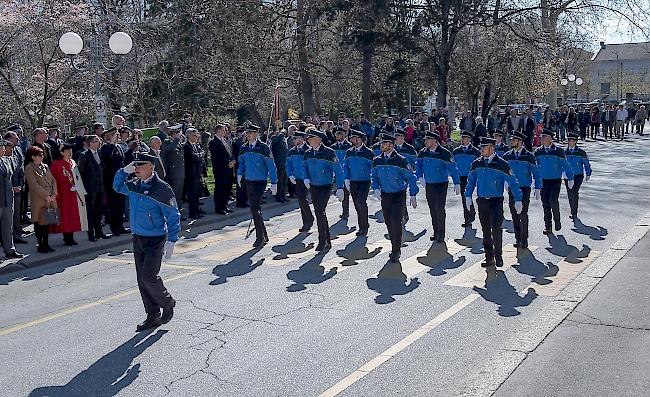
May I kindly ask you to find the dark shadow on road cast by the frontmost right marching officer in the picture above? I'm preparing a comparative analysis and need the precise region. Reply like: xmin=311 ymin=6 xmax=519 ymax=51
xmin=473 ymin=267 xmax=537 ymax=317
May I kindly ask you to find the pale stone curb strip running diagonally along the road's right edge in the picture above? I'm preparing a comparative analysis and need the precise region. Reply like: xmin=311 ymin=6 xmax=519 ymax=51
xmin=454 ymin=212 xmax=650 ymax=397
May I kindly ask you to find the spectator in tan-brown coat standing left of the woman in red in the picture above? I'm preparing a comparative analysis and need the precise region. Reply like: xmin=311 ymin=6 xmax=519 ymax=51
xmin=25 ymin=146 xmax=58 ymax=254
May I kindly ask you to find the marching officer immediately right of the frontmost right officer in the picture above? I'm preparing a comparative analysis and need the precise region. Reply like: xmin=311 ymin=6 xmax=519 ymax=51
xmin=503 ymin=131 xmax=542 ymax=248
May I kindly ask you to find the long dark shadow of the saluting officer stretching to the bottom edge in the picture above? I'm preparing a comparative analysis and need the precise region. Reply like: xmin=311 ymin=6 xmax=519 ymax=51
xmin=29 ymin=330 xmax=167 ymax=397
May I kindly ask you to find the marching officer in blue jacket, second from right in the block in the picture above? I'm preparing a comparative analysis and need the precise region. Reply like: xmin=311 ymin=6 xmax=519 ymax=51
xmin=535 ymin=128 xmax=574 ymax=235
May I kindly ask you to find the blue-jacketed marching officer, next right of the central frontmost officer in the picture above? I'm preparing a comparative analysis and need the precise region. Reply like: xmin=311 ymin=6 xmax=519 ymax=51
xmin=415 ymin=131 xmax=460 ymax=243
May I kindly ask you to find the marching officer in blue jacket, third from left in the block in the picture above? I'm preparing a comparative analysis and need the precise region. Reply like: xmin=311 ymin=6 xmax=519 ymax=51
xmin=303 ymin=127 xmax=343 ymax=251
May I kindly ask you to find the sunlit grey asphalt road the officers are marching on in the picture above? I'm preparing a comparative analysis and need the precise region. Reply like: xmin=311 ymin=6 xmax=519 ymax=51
xmin=0 ymin=137 xmax=650 ymax=396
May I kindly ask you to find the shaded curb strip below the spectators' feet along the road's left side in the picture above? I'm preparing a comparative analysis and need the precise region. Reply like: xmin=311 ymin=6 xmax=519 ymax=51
xmin=0 ymin=197 xmax=295 ymax=276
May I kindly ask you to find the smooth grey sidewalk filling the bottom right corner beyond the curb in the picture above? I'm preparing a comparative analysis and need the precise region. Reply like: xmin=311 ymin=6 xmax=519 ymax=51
xmin=494 ymin=229 xmax=650 ymax=397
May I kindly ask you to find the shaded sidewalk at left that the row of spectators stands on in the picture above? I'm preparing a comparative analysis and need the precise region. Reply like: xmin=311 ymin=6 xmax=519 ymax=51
xmin=0 ymin=192 xmax=297 ymax=274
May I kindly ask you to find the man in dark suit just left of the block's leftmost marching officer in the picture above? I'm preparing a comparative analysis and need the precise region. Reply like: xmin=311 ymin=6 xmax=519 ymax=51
xmin=209 ymin=124 xmax=236 ymax=215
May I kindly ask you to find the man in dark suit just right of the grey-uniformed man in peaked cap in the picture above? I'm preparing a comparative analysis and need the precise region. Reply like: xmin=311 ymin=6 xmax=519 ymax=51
xmin=183 ymin=127 xmax=205 ymax=219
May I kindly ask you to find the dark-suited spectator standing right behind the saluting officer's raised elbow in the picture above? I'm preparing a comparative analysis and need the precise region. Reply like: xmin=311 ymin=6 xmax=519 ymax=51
xmin=99 ymin=127 xmax=128 ymax=236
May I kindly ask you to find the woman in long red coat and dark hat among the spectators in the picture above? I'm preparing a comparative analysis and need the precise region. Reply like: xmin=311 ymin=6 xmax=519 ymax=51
xmin=50 ymin=144 xmax=88 ymax=245
